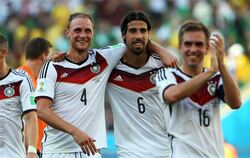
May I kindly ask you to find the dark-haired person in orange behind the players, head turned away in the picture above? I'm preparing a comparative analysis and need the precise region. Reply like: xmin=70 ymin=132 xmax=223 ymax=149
xmin=18 ymin=37 xmax=52 ymax=156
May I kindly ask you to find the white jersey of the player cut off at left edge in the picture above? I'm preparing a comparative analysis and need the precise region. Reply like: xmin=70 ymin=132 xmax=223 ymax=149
xmin=0 ymin=69 xmax=36 ymax=158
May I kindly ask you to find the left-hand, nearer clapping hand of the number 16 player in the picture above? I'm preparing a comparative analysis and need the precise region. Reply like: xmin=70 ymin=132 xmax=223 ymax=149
xmin=208 ymin=40 xmax=218 ymax=74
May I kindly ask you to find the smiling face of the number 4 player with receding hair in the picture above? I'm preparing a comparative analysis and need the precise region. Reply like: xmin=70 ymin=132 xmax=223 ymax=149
xmin=66 ymin=17 xmax=94 ymax=54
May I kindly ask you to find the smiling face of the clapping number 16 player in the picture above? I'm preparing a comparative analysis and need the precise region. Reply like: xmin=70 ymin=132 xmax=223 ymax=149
xmin=179 ymin=31 xmax=208 ymax=67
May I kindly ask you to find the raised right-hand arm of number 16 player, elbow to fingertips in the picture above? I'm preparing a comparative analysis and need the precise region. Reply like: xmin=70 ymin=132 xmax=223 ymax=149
xmin=211 ymin=33 xmax=241 ymax=109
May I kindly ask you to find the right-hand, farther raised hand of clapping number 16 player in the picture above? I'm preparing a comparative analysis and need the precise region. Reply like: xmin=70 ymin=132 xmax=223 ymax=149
xmin=210 ymin=33 xmax=225 ymax=67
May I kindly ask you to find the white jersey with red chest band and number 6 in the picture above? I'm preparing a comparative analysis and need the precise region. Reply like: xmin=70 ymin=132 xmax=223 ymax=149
xmin=107 ymin=56 xmax=170 ymax=158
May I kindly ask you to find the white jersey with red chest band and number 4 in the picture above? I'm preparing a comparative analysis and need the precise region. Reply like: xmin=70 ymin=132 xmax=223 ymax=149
xmin=35 ymin=45 xmax=125 ymax=153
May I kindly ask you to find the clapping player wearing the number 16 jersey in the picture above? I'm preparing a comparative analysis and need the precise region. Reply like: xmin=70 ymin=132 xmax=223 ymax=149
xmin=156 ymin=21 xmax=241 ymax=158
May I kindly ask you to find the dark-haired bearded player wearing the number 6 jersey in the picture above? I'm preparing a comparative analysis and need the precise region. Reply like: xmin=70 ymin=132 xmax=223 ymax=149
xmin=107 ymin=11 xmax=170 ymax=158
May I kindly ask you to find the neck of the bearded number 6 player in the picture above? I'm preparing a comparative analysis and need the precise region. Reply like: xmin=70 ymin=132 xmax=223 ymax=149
xmin=122 ymin=50 xmax=149 ymax=67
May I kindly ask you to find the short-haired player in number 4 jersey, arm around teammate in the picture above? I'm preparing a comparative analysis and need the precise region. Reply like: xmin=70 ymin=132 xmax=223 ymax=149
xmin=36 ymin=13 xmax=175 ymax=158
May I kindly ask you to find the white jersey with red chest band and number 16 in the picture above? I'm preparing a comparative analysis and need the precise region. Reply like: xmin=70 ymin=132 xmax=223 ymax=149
xmin=156 ymin=68 xmax=224 ymax=158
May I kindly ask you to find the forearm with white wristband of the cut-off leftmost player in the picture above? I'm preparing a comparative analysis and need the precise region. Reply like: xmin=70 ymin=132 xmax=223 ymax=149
xmin=23 ymin=111 xmax=38 ymax=158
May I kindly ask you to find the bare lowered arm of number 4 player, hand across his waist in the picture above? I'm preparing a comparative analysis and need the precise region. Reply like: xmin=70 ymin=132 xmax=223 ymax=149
xmin=37 ymin=98 xmax=97 ymax=155
